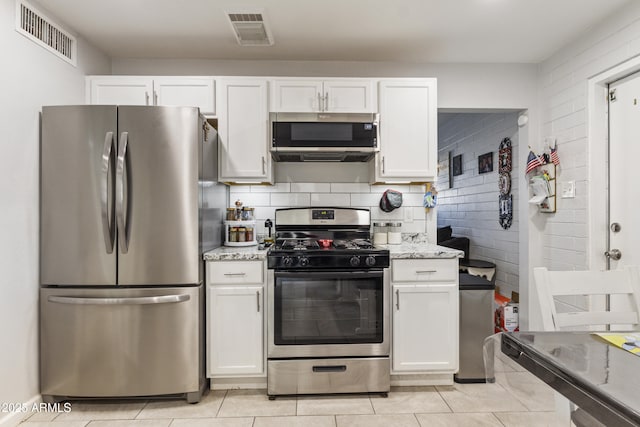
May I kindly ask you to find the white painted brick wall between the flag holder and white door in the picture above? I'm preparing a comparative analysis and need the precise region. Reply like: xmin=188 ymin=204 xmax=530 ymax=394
xmin=530 ymin=2 xmax=640 ymax=270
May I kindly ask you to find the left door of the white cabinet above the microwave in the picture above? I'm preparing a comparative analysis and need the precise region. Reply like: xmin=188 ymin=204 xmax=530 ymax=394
xmin=271 ymin=79 xmax=323 ymax=113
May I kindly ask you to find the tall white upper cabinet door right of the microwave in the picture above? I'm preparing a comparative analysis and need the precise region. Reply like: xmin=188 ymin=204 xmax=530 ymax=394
xmin=375 ymin=79 xmax=438 ymax=182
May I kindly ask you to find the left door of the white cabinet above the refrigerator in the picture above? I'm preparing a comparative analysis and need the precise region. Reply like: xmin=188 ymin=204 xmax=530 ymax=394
xmin=88 ymin=77 xmax=153 ymax=105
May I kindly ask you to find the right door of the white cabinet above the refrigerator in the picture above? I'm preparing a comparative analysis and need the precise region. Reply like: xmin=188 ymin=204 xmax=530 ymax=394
xmin=153 ymin=78 xmax=215 ymax=114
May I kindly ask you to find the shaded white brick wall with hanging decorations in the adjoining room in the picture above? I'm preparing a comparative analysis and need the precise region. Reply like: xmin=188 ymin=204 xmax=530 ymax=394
xmin=437 ymin=113 xmax=522 ymax=296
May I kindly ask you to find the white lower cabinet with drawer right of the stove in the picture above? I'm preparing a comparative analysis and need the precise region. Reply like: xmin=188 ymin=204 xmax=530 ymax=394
xmin=391 ymin=259 xmax=459 ymax=374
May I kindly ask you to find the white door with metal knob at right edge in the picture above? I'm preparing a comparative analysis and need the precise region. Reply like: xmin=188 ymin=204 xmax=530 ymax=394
xmin=609 ymin=73 xmax=640 ymax=269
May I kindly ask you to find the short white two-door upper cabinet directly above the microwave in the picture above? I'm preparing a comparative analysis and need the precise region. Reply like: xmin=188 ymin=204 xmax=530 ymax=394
xmin=271 ymin=79 xmax=376 ymax=113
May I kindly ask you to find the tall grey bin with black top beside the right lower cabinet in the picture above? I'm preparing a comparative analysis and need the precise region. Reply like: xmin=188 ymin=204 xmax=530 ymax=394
xmin=454 ymin=273 xmax=496 ymax=383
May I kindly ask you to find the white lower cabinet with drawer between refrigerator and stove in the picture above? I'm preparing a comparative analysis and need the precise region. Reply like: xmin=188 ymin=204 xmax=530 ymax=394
xmin=207 ymin=261 xmax=266 ymax=378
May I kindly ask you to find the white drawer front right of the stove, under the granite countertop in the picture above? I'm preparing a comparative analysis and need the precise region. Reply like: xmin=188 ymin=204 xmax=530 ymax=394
xmin=391 ymin=259 xmax=458 ymax=282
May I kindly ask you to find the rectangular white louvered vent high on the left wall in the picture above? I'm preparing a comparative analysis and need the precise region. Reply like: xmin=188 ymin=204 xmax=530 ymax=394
xmin=16 ymin=0 xmax=77 ymax=66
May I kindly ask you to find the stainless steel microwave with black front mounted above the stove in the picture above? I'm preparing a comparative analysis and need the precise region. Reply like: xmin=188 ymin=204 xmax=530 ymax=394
xmin=270 ymin=113 xmax=378 ymax=162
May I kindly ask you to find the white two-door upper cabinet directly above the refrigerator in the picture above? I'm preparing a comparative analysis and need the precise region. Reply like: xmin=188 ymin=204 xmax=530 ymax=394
xmin=87 ymin=76 xmax=215 ymax=115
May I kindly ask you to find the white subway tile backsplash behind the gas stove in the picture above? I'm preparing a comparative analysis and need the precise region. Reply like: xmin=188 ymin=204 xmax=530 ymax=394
xmin=229 ymin=182 xmax=435 ymax=239
